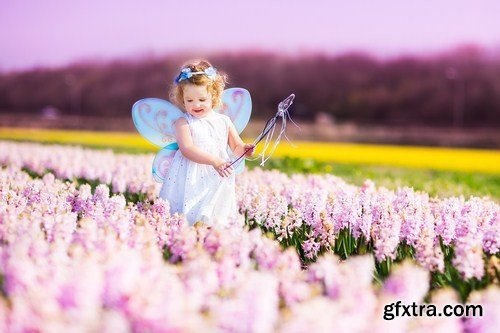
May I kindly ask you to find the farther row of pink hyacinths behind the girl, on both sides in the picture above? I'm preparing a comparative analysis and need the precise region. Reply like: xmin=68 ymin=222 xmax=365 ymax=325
xmin=0 ymin=142 xmax=500 ymax=290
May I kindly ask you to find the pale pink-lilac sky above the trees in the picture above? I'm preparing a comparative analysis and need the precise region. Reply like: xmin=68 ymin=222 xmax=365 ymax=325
xmin=0 ymin=0 xmax=500 ymax=70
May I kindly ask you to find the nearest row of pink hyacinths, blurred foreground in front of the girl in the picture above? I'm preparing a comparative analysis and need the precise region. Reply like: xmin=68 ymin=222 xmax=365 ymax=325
xmin=0 ymin=166 xmax=500 ymax=333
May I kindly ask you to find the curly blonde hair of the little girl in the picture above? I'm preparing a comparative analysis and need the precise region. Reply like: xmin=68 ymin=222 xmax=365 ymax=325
xmin=169 ymin=60 xmax=227 ymax=109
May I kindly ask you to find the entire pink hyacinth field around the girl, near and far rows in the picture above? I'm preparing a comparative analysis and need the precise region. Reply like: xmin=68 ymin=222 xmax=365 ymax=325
xmin=0 ymin=141 xmax=500 ymax=332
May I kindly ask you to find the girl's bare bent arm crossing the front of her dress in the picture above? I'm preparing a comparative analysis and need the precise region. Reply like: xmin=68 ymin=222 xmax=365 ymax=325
xmin=175 ymin=118 xmax=233 ymax=176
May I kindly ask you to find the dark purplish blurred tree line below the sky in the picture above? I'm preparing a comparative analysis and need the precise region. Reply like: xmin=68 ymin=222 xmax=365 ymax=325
xmin=0 ymin=47 xmax=500 ymax=127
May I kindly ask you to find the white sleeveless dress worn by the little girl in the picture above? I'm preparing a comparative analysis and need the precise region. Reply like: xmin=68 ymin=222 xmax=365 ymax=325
xmin=160 ymin=111 xmax=237 ymax=226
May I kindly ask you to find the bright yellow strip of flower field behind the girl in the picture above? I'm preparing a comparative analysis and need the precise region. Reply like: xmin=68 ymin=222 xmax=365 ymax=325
xmin=0 ymin=128 xmax=500 ymax=174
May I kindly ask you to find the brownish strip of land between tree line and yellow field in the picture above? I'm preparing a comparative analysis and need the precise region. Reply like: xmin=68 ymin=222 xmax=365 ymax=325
xmin=0 ymin=110 xmax=500 ymax=149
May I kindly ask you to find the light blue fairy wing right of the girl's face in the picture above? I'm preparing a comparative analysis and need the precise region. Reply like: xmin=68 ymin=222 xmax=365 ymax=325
xmin=217 ymin=88 xmax=252 ymax=133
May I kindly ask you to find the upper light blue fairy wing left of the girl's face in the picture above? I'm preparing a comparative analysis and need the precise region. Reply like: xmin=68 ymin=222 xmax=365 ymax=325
xmin=132 ymin=98 xmax=183 ymax=147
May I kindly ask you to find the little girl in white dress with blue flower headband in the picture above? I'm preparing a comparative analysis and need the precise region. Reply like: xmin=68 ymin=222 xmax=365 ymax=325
xmin=160 ymin=60 xmax=255 ymax=226
